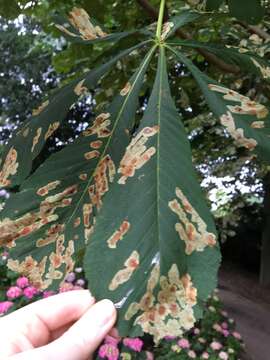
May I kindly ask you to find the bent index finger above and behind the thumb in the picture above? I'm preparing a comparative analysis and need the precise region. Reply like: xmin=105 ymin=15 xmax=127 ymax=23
xmin=0 ymin=290 xmax=94 ymax=356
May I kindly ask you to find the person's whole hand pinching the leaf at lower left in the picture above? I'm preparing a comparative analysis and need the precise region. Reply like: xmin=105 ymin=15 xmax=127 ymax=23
xmin=0 ymin=290 xmax=116 ymax=360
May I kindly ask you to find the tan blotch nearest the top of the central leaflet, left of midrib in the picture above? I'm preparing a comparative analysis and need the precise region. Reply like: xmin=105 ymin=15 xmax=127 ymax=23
xmin=117 ymin=126 xmax=159 ymax=184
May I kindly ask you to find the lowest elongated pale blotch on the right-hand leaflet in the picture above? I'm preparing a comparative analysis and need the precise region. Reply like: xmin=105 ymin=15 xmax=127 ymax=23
xmin=220 ymin=111 xmax=258 ymax=150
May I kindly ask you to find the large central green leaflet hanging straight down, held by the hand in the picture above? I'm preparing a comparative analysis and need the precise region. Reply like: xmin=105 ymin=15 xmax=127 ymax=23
xmin=84 ymin=50 xmax=220 ymax=341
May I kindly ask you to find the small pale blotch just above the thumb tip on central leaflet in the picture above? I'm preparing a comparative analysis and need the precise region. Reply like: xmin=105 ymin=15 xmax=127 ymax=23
xmin=109 ymin=251 xmax=140 ymax=291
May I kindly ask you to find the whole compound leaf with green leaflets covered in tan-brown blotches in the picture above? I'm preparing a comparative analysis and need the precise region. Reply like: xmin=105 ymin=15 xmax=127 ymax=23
xmin=0 ymin=2 xmax=269 ymax=342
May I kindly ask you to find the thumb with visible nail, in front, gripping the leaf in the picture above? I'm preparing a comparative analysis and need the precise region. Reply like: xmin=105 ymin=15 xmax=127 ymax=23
xmin=10 ymin=300 xmax=116 ymax=360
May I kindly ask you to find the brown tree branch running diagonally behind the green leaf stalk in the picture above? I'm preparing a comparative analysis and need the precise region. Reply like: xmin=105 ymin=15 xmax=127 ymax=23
xmin=136 ymin=0 xmax=240 ymax=74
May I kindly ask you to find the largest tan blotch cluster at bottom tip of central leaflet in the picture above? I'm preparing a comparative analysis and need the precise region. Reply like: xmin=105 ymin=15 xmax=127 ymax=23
xmin=125 ymin=264 xmax=197 ymax=343
